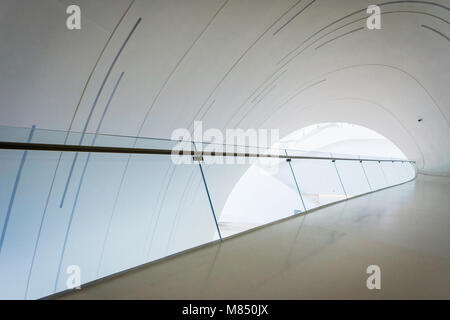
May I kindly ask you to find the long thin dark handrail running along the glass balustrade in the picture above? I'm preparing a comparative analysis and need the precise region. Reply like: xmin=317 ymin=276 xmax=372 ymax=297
xmin=0 ymin=142 xmax=415 ymax=163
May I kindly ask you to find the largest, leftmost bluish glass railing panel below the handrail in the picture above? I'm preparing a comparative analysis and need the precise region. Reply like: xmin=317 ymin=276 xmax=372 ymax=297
xmin=0 ymin=150 xmax=218 ymax=299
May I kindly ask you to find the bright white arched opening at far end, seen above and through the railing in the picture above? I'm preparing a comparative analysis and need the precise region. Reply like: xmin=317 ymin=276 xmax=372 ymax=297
xmin=219 ymin=122 xmax=414 ymax=236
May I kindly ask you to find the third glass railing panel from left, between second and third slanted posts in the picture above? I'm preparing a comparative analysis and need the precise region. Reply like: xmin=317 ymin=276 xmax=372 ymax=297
xmin=291 ymin=159 xmax=346 ymax=210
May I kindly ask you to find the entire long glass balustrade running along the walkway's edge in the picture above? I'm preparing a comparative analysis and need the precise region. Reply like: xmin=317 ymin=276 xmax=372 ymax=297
xmin=0 ymin=127 xmax=416 ymax=299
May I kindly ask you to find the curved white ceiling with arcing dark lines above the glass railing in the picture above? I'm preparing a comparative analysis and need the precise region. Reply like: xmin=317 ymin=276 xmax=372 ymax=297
xmin=0 ymin=0 xmax=450 ymax=175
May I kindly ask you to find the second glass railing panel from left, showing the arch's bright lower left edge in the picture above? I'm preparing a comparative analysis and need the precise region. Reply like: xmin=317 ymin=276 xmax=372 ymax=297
xmin=202 ymin=157 xmax=304 ymax=238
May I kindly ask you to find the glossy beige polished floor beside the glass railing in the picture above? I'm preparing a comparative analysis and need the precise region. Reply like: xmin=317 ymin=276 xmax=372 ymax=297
xmin=60 ymin=175 xmax=450 ymax=299
